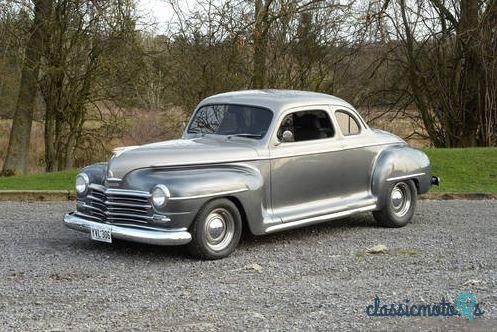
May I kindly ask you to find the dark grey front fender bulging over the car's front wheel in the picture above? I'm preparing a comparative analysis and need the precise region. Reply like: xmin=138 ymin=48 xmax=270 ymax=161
xmin=121 ymin=163 xmax=267 ymax=231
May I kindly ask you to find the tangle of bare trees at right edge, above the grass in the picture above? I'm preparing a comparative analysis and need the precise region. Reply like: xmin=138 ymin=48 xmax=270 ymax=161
xmin=364 ymin=0 xmax=497 ymax=147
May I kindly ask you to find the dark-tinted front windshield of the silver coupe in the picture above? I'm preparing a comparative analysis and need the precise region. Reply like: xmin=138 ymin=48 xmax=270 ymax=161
xmin=188 ymin=104 xmax=273 ymax=139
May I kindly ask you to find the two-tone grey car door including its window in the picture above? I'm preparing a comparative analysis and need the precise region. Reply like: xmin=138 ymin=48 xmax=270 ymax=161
xmin=270 ymin=105 xmax=346 ymax=222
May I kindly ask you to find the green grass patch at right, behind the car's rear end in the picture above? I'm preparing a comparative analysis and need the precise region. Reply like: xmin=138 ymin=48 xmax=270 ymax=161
xmin=424 ymin=148 xmax=497 ymax=193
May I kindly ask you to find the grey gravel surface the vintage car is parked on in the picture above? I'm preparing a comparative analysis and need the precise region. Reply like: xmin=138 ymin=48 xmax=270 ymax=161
xmin=0 ymin=201 xmax=497 ymax=330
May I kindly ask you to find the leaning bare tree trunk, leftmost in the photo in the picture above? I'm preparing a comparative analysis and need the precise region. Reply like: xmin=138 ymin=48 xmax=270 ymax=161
xmin=2 ymin=0 xmax=50 ymax=174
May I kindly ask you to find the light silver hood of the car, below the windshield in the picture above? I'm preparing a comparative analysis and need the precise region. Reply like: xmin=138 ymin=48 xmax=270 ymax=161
xmin=108 ymin=137 xmax=259 ymax=178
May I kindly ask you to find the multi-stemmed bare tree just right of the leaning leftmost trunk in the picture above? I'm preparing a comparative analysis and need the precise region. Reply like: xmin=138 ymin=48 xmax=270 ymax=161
xmin=37 ymin=0 xmax=140 ymax=171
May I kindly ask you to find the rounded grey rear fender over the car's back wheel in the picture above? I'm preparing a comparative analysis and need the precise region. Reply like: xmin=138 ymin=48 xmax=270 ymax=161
xmin=371 ymin=145 xmax=431 ymax=208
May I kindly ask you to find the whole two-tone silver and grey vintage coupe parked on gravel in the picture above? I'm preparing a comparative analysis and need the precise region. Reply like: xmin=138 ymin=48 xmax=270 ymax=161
xmin=64 ymin=90 xmax=438 ymax=259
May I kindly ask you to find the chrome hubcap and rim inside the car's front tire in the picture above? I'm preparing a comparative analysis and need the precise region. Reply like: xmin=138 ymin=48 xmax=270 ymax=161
xmin=205 ymin=208 xmax=235 ymax=251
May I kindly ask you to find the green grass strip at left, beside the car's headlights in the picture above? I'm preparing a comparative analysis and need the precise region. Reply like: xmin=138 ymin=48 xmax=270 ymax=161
xmin=0 ymin=170 xmax=78 ymax=190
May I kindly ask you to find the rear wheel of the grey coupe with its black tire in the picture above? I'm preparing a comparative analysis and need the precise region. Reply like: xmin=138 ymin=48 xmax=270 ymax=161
xmin=373 ymin=180 xmax=417 ymax=227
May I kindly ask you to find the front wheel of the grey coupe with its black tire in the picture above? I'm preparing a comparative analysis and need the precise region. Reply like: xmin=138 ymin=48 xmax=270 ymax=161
xmin=188 ymin=198 xmax=242 ymax=259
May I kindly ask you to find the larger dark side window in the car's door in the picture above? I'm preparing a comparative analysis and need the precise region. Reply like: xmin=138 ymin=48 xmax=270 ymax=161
xmin=277 ymin=110 xmax=335 ymax=142
